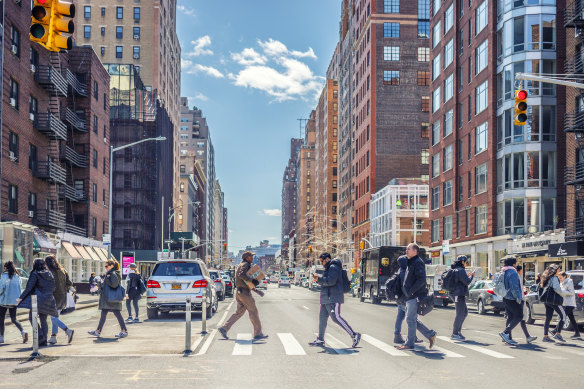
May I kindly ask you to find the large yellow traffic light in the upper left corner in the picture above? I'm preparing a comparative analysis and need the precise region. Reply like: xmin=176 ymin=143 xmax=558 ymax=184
xmin=29 ymin=0 xmax=75 ymax=52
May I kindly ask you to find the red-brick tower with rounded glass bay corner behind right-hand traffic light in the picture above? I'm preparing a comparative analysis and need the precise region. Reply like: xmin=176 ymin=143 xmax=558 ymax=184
xmin=430 ymin=0 xmax=565 ymax=274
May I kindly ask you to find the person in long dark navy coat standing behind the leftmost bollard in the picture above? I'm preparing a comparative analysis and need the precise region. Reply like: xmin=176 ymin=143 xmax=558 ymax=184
xmin=16 ymin=258 xmax=58 ymax=347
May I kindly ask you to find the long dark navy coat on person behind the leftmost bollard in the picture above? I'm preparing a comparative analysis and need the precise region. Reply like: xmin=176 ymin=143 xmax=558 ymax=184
xmin=18 ymin=270 xmax=59 ymax=316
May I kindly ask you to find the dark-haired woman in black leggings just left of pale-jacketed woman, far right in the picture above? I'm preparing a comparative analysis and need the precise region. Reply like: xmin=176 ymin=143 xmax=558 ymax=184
xmin=539 ymin=263 xmax=566 ymax=343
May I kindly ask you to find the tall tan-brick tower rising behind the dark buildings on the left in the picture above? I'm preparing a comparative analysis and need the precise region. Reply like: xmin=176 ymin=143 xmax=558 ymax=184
xmin=75 ymin=0 xmax=181 ymax=230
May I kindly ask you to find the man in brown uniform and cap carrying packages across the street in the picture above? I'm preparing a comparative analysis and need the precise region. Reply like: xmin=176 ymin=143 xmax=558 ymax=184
xmin=218 ymin=251 xmax=268 ymax=340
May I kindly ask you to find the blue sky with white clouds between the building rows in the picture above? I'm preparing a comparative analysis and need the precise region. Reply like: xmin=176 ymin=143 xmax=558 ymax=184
xmin=177 ymin=0 xmax=341 ymax=252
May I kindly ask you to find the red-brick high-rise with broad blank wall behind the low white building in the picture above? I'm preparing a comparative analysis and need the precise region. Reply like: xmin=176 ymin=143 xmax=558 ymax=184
xmin=352 ymin=0 xmax=429 ymax=263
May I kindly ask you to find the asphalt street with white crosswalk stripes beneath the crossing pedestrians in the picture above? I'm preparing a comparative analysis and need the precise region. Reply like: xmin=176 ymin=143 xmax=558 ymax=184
xmin=0 ymin=285 xmax=584 ymax=389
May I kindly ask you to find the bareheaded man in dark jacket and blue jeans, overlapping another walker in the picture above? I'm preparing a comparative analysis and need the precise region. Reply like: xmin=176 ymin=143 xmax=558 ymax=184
xmin=397 ymin=243 xmax=437 ymax=350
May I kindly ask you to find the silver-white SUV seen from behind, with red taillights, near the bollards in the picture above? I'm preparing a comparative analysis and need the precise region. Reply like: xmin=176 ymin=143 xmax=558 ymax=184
xmin=146 ymin=259 xmax=219 ymax=319
